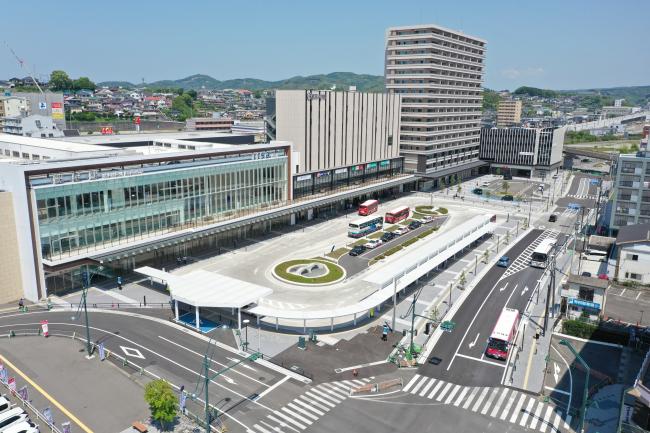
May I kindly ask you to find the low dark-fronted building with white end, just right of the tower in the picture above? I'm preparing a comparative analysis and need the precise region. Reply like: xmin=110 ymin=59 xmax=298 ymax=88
xmin=479 ymin=128 xmax=566 ymax=177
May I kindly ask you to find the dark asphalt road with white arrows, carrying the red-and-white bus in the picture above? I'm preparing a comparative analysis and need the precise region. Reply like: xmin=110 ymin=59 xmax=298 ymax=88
xmin=419 ymin=230 xmax=543 ymax=386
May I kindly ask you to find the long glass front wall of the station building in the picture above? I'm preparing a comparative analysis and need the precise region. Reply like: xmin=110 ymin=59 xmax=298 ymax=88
xmin=34 ymin=155 xmax=288 ymax=260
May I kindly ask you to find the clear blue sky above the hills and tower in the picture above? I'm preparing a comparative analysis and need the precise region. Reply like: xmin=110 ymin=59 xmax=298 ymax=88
xmin=0 ymin=0 xmax=650 ymax=90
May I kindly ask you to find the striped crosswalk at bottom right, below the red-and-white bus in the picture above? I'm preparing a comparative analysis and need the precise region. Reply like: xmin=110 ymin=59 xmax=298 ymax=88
xmin=402 ymin=374 xmax=572 ymax=433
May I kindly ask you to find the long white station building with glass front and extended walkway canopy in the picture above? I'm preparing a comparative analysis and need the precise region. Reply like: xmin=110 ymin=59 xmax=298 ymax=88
xmin=0 ymin=130 xmax=413 ymax=302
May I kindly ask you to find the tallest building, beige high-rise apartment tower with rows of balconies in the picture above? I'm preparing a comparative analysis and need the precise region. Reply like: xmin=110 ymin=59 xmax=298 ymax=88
xmin=385 ymin=25 xmax=486 ymax=182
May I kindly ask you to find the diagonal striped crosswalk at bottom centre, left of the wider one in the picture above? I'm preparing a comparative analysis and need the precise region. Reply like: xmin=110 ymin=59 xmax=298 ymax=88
xmin=253 ymin=378 xmax=370 ymax=433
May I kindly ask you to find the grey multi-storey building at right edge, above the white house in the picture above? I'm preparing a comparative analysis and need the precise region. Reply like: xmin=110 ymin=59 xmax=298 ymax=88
xmin=609 ymin=136 xmax=650 ymax=232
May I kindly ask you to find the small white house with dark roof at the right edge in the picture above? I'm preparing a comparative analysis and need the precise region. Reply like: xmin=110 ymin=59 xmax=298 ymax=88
xmin=615 ymin=223 xmax=650 ymax=284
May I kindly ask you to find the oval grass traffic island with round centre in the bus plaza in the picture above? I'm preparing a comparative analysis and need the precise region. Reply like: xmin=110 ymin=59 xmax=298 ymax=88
xmin=273 ymin=258 xmax=346 ymax=286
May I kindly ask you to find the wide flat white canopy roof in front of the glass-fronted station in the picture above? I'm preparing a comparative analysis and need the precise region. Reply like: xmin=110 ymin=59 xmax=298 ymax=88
xmin=135 ymin=266 xmax=273 ymax=308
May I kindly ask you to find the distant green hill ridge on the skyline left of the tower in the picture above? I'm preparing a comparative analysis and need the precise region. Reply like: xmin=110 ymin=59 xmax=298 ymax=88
xmin=97 ymin=72 xmax=384 ymax=92
